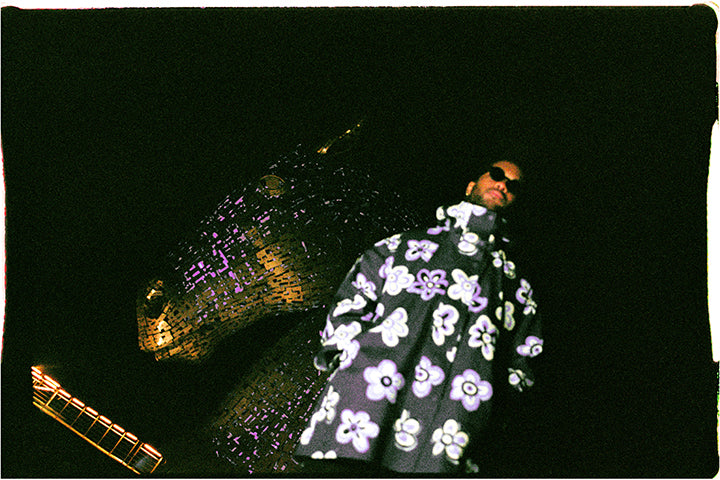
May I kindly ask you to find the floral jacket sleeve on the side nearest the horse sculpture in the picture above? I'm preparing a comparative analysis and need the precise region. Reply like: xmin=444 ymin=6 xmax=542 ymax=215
xmin=314 ymin=236 xmax=397 ymax=371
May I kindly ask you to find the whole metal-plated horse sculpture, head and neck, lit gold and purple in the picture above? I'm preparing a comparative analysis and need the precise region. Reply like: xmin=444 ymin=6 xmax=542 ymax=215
xmin=137 ymin=122 xmax=418 ymax=473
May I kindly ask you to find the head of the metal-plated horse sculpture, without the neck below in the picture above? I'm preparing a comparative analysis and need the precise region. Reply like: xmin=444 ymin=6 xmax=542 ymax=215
xmin=137 ymin=121 xmax=417 ymax=361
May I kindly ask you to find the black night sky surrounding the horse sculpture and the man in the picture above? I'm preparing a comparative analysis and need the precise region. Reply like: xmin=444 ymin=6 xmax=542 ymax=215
xmin=2 ymin=7 xmax=718 ymax=477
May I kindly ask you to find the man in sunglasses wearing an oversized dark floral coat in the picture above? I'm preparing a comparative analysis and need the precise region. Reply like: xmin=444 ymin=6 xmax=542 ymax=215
xmin=296 ymin=160 xmax=543 ymax=476
